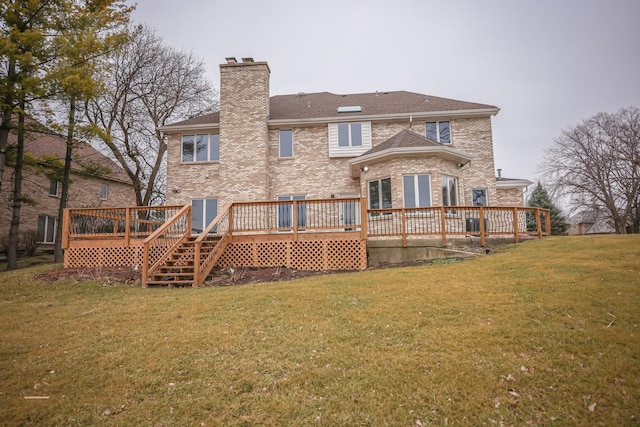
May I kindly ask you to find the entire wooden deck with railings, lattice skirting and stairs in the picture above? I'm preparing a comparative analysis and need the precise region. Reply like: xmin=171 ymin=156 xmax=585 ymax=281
xmin=63 ymin=198 xmax=551 ymax=286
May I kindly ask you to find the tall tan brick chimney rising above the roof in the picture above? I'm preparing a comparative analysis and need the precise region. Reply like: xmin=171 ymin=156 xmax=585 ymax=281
xmin=219 ymin=57 xmax=270 ymax=204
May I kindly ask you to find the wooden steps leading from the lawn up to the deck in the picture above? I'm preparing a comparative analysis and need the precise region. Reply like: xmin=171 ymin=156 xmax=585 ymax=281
xmin=147 ymin=236 xmax=220 ymax=287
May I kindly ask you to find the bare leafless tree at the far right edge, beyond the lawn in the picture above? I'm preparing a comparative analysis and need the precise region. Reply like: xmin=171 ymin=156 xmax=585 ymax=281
xmin=541 ymin=107 xmax=640 ymax=233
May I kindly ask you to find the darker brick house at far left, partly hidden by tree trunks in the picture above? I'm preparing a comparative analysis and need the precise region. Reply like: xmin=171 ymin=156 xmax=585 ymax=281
xmin=0 ymin=128 xmax=135 ymax=244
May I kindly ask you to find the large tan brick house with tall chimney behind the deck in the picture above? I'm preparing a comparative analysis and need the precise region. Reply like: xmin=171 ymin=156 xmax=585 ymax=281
xmin=160 ymin=58 xmax=531 ymax=234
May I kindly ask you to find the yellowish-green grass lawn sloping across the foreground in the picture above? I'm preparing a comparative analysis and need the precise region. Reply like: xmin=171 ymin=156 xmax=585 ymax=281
xmin=0 ymin=236 xmax=640 ymax=426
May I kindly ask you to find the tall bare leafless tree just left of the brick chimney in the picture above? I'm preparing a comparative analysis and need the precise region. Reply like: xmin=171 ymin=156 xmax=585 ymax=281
xmin=86 ymin=26 xmax=216 ymax=206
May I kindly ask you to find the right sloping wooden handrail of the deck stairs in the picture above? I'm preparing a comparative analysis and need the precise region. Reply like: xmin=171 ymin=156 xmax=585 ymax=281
xmin=193 ymin=203 xmax=233 ymax=287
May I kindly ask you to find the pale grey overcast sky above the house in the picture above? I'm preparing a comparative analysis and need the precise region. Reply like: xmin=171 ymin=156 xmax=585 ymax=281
xmin=131 ymin=0 xmax=640 ymax=181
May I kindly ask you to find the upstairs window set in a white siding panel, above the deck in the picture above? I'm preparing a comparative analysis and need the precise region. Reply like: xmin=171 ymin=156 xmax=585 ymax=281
xmin=329 ymin=122 xmax=372 ymax=157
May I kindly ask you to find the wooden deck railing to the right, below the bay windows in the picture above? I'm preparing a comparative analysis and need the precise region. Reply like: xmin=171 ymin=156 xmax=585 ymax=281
xmin=367 ymin=206 xmax=551 ymax=246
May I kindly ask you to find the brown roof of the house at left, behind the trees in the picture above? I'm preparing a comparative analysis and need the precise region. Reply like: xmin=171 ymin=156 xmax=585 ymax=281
xmin=9 ymin=126 xmax=131 ymax=184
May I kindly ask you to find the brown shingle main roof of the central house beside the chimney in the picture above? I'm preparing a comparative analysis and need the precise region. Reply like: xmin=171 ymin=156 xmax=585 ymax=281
xmin=160 ymin=91 xmax=500 ymax=131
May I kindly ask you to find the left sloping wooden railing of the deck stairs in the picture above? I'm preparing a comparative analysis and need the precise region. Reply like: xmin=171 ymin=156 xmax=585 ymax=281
xmin=142 ymin=205 xmax=191 ymax=287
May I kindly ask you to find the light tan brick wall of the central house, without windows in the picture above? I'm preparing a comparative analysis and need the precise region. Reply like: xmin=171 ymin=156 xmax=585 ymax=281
xmin=167 ymin=118 xmax=508 ymax=207
